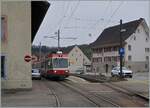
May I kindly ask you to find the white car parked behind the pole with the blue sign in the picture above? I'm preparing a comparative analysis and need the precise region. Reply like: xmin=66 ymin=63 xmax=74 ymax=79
xmin=111 ymin=67 xmax=133 ymax=78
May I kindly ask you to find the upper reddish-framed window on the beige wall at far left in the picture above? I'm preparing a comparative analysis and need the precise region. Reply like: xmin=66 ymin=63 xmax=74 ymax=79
xmin=1 ymin=15 xmax=7 ymax=41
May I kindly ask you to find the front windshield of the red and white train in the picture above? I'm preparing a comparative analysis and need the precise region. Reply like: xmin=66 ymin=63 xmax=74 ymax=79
xmin=53 ymin=58 xmax=68 ymax=68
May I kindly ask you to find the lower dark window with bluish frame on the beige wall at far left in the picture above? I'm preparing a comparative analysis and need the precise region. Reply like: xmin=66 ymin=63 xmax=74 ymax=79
xmin=1 ymin=56 xmax=6 ymax=78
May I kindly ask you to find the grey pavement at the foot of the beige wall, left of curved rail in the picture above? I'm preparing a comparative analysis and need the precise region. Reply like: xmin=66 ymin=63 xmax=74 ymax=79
xmin=1 ymin=81 xmax=55 ymax=107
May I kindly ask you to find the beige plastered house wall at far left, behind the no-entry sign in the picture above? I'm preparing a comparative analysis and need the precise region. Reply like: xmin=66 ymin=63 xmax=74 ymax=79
xmin=1 ymin=1 xmax=49 ymax=89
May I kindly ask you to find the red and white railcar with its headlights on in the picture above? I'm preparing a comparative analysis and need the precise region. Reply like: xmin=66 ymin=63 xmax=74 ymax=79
xmin=41 ymin=53 xmax=69 ymax=79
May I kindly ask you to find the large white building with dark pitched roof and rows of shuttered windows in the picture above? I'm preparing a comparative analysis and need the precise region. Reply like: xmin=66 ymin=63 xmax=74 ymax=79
xmin=91 ymin=18 xmax=150 ymax=72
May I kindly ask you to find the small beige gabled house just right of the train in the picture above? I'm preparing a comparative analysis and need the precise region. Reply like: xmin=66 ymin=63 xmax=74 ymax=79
xmin=68 ymin=46 xmax=91 ymax=73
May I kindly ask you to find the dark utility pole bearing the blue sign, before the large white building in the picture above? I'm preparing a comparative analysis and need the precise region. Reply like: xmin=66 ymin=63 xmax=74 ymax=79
xmin=120 ymin=19 xmax=123 ymax=77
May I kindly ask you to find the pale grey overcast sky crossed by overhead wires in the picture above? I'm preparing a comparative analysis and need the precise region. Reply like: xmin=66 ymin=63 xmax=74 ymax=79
xmin=33 ymin=1 xmax=150 ymax=47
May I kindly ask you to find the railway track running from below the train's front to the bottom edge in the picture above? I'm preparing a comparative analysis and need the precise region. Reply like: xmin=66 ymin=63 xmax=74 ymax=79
xmin=59 ymin=82 xmax=120 ymax=107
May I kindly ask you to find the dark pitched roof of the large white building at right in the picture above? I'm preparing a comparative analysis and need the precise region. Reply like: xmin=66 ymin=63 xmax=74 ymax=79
xmin=90 ymin=18 xmax=144 ymax=48
